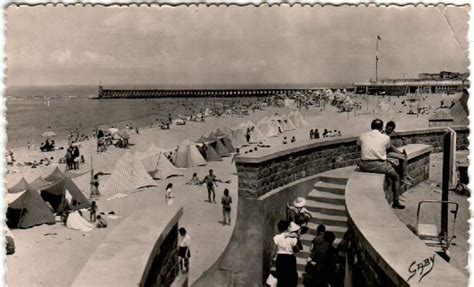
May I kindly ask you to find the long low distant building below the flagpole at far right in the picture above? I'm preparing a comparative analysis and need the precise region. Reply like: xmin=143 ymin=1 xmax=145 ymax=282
xmin=354 ymin=71 xmax=469 ymax=96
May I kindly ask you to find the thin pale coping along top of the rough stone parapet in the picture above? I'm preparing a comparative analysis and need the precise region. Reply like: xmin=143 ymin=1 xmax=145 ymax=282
xmin=235 ymin=126 xmax=469 ymax=164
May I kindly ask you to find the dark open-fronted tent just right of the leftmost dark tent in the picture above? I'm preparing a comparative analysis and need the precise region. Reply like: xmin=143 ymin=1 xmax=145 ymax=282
xmin=39 ymin=177 xmax=90 ymax=213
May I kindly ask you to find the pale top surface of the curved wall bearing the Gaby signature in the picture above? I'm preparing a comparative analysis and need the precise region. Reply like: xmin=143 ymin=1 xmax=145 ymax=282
xmin=346 ymin=172 xmax=468 ymax=287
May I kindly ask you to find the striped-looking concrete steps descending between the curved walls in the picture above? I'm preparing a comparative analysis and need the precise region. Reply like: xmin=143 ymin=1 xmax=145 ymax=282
xmin=296 ymin=166 xmax=355 ymax=286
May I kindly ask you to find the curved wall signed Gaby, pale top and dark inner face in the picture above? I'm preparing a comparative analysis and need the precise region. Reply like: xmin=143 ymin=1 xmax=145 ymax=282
xmin=346 ymin=172 xmax=468 ymax=287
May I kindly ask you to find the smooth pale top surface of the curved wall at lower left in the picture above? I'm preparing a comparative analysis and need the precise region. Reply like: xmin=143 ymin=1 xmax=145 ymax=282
xmin=72 ymin=207 xmax=183 ymax=286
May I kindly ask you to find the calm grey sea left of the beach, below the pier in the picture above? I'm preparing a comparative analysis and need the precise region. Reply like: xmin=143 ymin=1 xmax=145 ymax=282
xmin=6 ymin=86 xmax=254 ymax=148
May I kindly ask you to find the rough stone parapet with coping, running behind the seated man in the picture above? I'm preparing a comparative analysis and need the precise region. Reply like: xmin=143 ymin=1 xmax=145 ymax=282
xmin=236 ymin=126 xmax=469 ymax=198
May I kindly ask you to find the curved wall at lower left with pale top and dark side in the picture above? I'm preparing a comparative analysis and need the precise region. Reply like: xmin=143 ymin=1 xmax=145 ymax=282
xmin=72 ymin=207 xmax=183 ymax=286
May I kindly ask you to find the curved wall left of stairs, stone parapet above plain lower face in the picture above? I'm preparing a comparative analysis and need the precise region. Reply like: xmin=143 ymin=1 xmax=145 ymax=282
xmin=194 ymin=126 xmax=469 ymax=286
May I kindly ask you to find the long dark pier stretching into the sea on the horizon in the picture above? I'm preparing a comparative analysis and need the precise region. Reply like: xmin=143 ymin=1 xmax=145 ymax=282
xmin=98 ymin=86 xmax=317 ymax=99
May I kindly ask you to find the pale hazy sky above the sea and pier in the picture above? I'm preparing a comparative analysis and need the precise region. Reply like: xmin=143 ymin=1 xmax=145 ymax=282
xmin=6 ymin=5 xmax=469 ymax=87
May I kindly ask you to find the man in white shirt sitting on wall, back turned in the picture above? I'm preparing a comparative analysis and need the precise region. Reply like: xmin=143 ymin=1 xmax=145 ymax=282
xmin=357 ymin=119 xmax=405 ymax=209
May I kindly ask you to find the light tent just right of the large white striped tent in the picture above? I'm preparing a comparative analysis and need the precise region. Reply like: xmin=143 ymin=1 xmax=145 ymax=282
xmin=135 ymin=149 xmax=183 ymax=179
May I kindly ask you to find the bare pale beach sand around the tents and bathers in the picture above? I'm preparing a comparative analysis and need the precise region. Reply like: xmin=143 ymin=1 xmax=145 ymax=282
xmin=6 ymin=94 xmax=456 ymax=286
